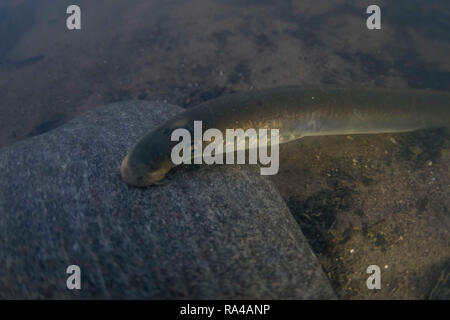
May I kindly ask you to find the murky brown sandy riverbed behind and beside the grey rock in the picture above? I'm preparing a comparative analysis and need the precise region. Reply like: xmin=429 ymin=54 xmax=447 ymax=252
xmin=0 ymin=0 xmax=450 ymax=298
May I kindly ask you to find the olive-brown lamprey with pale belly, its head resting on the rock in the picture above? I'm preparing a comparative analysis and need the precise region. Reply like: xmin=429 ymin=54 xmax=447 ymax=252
xmin=121 ymin=87 xmax=450 ymax=186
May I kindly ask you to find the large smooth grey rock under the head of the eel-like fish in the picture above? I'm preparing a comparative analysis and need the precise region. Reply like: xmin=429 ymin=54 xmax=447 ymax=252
xmin=0 ymin=101 xmax=335 ymax=299
